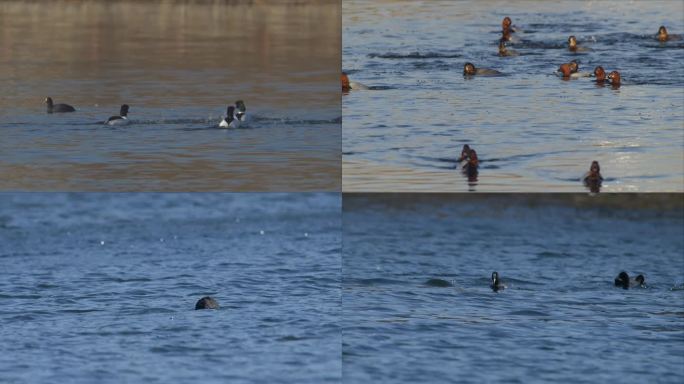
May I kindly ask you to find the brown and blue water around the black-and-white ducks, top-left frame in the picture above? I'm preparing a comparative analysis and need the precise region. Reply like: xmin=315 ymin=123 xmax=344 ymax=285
xmin=0 ymin=1 xmax=341 ymax=192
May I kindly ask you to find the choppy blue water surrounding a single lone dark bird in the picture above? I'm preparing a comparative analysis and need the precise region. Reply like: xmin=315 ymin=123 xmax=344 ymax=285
xmin=0 ymin=194 xmax=341 ymax=383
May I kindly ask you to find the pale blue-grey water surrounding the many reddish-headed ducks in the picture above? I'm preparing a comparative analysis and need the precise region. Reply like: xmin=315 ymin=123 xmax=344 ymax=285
xmin=342 ymin=1 xmax=684 ymax=192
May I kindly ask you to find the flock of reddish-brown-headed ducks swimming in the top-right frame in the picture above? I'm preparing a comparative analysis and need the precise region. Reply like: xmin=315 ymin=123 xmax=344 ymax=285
xmin=341 ymin=16 xmax=672 ymax=192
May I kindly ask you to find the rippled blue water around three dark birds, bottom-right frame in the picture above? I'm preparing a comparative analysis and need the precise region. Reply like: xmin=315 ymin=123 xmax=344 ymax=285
xmin=342 ymin=195 xmax=684 ymax=383
